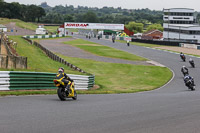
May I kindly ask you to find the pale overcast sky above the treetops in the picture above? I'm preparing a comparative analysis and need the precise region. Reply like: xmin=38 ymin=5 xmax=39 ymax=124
xmin=4 ymin=0 xmax=200 ymax=12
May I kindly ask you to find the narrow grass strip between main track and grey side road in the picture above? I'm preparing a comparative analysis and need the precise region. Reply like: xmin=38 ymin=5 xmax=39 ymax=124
xmin=64 ymin=39 xmax=147 ymax=61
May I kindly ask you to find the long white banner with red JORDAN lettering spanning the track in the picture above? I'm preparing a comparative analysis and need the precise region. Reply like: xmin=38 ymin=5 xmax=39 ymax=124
xmin=64 ymin=22 xmax=124 ymax=30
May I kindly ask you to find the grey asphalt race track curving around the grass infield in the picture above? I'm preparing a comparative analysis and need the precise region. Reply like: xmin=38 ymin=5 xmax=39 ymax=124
xmin=0 ymin=37 xmax=200 ymax=133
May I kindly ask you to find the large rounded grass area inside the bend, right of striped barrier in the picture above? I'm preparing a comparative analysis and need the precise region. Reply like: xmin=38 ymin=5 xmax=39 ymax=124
xmin=59 ymin=55 xmax=172 ymax=94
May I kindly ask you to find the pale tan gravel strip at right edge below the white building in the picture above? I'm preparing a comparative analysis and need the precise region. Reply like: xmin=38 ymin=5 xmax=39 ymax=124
xmin=155 ymin=46 xmax=200 ymax=55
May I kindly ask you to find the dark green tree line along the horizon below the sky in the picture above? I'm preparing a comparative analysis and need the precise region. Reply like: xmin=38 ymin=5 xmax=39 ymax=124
xmin=0 ymin=0 xmax=200 ymax=33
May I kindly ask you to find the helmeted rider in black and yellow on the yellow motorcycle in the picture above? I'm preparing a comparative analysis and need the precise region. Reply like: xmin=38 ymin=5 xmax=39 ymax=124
xmin=56 ymin=67 xmax=73 ymax=93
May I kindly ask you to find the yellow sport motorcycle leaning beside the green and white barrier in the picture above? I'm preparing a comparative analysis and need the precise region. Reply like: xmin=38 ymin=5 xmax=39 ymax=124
xmin=53 ymin=79 xmax=77 ymax=101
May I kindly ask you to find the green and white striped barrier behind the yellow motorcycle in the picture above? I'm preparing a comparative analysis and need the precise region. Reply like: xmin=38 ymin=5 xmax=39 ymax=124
xmin=0 ymin=71 xmax=95 ymax=90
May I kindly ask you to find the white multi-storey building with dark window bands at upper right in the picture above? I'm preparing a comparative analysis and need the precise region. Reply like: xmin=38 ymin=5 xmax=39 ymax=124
xmin=163 ymin=8 xmax=200 ymax=43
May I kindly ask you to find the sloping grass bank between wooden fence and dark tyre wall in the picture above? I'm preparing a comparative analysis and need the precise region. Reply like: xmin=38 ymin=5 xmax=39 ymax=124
xmin=9 ymin=36 xmax=86 ymax=74
